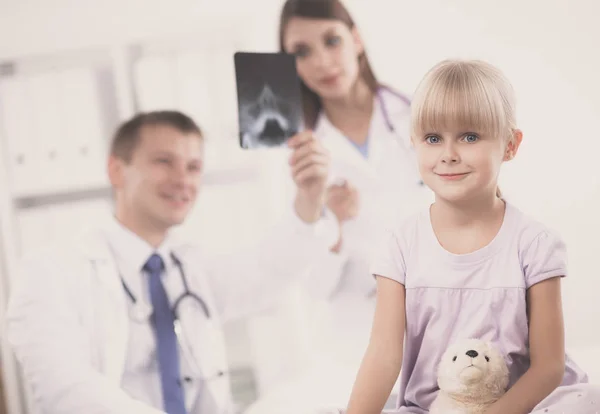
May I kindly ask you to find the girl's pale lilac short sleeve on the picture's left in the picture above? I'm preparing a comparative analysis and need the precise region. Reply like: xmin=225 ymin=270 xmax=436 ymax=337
xmin=371 ymin=226 xmax=406 ymax=285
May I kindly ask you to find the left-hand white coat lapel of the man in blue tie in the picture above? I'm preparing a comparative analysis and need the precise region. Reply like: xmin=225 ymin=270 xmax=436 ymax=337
xmin=80 ymin=234 xmax=129 ymax=383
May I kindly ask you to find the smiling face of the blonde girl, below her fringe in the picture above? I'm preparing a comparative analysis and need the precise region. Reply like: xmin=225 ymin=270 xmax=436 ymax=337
xmin=413 ymin=129 xmax=522 ymax=202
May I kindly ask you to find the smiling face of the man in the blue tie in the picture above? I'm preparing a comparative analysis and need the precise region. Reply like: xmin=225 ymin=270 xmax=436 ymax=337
xmin=109 ymin=125 xmax=203 ymax=230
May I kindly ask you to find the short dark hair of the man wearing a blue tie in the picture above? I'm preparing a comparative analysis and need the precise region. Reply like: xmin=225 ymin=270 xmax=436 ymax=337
xmin=110 ymin=111 xmax=202 ymax=162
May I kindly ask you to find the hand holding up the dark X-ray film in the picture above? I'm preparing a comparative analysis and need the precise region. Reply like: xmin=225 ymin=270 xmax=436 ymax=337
xmin=288 ymin=131 xmax=330 ymax=223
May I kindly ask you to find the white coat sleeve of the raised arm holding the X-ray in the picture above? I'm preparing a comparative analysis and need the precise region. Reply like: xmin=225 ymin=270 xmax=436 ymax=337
xmin=208 ymin=204 xmax=337 ymax=319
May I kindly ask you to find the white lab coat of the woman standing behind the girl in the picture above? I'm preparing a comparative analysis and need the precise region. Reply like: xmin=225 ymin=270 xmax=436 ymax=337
xmin=305 ymin=88 xmax=434 ymax=370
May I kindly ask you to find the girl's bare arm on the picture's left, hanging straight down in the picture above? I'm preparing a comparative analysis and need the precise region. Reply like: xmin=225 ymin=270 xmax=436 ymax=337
xmin=347 ymin=276 xmax=406 ymax=414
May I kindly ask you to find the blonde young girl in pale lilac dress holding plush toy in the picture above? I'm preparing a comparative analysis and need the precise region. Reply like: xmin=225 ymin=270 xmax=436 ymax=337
xmin=347 ymin=61 xmax=600 ymax=414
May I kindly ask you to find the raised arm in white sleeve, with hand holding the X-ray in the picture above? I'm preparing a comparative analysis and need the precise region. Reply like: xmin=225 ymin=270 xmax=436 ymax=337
xmin=204 ymin=132 xmax=339 ymax=318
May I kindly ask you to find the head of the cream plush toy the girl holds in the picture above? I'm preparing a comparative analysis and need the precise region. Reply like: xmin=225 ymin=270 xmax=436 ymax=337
xmin=438 ymin=339 xmax=508 ymax=401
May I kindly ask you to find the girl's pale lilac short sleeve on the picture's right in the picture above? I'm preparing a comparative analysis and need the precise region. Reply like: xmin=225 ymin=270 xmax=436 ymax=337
xmin=522 ymin=230 xmax=567 ymax=289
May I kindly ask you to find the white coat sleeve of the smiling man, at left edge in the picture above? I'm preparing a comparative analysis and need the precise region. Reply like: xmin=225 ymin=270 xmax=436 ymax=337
xmin=6 ymin=249 xmax=164 ymax=414
